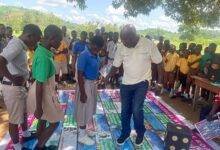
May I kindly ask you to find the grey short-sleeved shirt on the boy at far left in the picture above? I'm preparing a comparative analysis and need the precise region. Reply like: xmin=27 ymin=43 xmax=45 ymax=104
xmin=0 ymin=37 xmax=29 ymax=79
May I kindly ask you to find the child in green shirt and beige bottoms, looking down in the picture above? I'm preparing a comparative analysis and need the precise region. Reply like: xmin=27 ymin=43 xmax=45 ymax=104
xmin=27 ymin=25 xmax=64 ymax=150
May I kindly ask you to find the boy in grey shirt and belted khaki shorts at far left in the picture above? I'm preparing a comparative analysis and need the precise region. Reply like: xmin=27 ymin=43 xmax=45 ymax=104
xmin=0 ymin=24 xmax=42 ymax=150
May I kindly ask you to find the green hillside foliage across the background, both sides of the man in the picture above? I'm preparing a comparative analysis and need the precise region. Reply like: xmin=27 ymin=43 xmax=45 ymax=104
xmin=0 ymin=6 xmax=220 ymax=53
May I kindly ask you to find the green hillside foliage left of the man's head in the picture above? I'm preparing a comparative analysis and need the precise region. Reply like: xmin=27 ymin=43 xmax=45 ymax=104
xmin=0 ymin=6 xmax=119 ymax=35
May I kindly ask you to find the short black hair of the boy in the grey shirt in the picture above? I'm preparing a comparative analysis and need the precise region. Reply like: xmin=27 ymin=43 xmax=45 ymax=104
xmin=22 ymin=24 xmax=42 ymax=37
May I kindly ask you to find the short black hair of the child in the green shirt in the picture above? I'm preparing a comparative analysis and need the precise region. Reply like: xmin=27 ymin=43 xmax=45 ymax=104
xmin=44 ymin=25 xmax=62 ymax=39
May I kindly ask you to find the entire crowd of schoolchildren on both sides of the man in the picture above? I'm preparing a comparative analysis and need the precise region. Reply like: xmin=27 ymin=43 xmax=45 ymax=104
xmin=0 ymin=24 xmax=220 ymax=149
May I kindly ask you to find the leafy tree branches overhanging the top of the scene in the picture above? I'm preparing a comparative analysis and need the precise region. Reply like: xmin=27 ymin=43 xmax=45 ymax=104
xmin=67 ymin=0 xmax=220 ymax=27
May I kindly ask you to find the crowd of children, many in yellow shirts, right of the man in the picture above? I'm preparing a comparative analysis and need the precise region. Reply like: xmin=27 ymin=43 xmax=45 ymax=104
xmin=156 ymin=37 xmax=220 ymax=101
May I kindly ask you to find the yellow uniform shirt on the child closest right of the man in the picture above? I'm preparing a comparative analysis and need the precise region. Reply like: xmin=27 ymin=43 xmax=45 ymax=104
xmin=164 ymin=53 xmax=179 ymax=72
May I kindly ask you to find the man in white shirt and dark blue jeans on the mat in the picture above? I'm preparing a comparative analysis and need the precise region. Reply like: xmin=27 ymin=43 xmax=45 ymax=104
xmin=106 ymin=25 xmax=162 ymax=146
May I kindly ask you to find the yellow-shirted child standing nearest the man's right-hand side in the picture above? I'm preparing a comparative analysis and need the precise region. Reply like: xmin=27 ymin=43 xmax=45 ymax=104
xmin=163 ymin=45 xmax=179 ymax=97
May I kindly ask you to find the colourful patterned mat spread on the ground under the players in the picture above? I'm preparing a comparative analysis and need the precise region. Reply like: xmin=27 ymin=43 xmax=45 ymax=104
xmin=1 ymin=90 xmax=217 ymax=150
